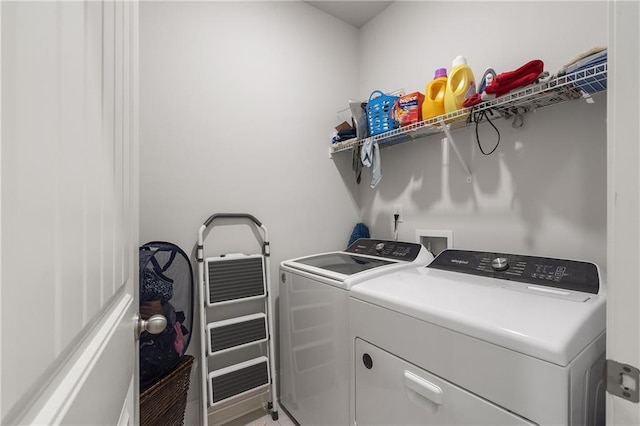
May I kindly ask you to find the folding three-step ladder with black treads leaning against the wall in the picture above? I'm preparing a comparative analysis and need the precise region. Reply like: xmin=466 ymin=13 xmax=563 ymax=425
xmin=196 ymin=213 xmax=278 ymax=426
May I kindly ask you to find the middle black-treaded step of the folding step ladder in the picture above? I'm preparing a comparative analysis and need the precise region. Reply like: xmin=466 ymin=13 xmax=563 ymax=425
xmin=207 ymin=313 xmax=269 ymax=356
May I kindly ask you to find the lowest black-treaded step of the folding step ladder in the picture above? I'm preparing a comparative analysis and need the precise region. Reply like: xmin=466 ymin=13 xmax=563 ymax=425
xmin=209 ymin=356 xmax=271 ymax=406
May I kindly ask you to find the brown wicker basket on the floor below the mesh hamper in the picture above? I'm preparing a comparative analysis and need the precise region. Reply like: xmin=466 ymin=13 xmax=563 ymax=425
xmin=140 ymin=355 xmax=194 ymax=426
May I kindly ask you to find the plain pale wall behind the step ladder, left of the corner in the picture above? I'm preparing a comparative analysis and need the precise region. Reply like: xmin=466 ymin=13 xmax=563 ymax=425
xmin=140 ymin=2 xmax=358 ymax=422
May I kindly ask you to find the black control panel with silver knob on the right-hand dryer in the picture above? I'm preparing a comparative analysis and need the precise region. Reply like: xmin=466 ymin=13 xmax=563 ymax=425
xmin=427 ymin=250 xmax=600 ymax=294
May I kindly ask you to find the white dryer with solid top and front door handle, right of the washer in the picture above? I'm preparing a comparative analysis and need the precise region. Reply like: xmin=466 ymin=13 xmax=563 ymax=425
xmin=349 ymin=250 xmax=606 ymax=426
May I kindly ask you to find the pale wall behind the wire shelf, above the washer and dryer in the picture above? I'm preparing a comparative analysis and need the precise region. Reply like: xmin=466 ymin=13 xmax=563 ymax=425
xmin=358 ymin=2 xmax=607 ymax=268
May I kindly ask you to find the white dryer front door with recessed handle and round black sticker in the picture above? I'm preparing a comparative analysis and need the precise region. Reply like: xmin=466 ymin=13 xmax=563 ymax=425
xmin=355 ymin=339 xmax=535 ymax=426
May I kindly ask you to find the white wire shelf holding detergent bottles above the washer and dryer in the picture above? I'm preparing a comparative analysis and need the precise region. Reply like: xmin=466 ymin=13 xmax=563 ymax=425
xmin=331 ymin=62 xmax=607 ymax=154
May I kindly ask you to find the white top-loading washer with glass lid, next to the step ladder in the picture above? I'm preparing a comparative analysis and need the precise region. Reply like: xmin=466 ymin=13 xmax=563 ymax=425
xmin=279 ymin=238 xmax=433 ymax=426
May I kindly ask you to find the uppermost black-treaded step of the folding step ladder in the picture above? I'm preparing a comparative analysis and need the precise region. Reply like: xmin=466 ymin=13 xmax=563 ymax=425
xmin=205 ymin=255 xmax=266 ymax=306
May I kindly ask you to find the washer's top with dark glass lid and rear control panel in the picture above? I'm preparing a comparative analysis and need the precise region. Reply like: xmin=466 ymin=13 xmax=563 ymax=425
xmin=281 ymin=238 xmax=433 ymax=289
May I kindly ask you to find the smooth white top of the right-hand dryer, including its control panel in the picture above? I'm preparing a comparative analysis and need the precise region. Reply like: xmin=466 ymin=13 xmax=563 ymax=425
xmin=350 ymin=250 xmax=606 ymax=366
